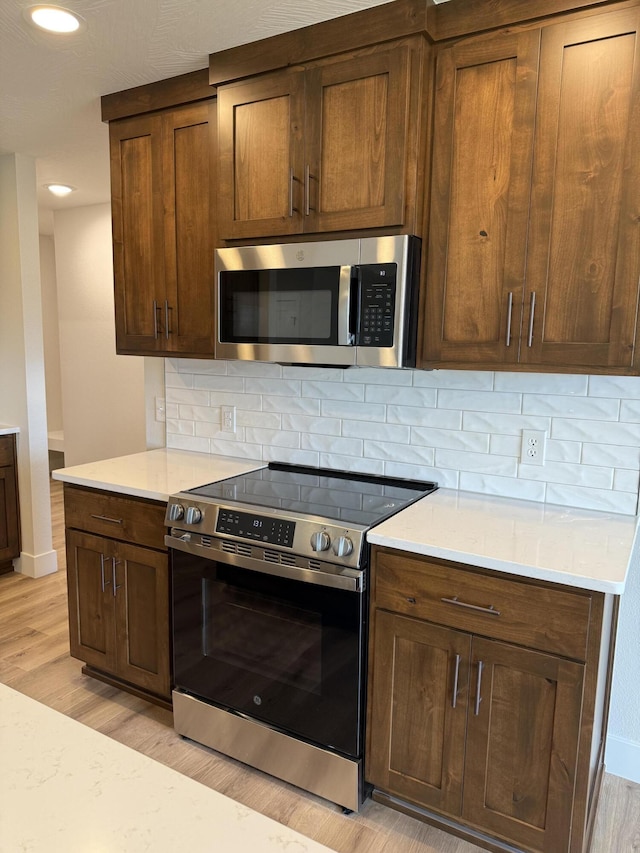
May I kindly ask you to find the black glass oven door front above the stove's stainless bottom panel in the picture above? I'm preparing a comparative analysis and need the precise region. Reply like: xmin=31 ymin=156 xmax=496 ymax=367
xmin=171 ymin=550 xmax=366 ymax=757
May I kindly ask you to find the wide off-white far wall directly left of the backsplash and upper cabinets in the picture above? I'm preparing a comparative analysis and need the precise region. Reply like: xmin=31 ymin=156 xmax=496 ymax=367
xmin=54 ymin=204 xmax=147 ymax=466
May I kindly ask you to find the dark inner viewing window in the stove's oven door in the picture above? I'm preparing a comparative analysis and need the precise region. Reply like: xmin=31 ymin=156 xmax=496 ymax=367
xmin=202 ymin=579 xmax=322 ymax=695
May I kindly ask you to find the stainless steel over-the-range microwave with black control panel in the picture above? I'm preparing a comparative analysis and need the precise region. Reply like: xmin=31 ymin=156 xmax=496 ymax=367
xmin=215 ymin=235 xmax=420 ymax=367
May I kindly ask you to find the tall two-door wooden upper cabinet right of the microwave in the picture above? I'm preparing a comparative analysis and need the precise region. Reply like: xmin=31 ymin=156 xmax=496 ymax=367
xmin=422 ymin=7 xmax=640 ymax=373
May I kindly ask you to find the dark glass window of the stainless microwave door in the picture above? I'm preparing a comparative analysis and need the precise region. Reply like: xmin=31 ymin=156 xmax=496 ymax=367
xmin=220 ymin=267 xmax=340 ymax=345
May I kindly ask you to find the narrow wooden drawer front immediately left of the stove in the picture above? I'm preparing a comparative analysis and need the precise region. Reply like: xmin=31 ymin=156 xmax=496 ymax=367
xmin=64 ymin=485 xmax=166 ymax=551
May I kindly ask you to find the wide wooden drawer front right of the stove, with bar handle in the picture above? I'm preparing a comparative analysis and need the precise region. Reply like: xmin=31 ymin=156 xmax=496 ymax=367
xmin=373 ymin=551 xmax=591 ymax=660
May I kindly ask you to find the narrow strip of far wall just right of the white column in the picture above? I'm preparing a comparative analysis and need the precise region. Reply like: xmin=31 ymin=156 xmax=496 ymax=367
xmin=40 ymin=234 xmax=62 ymax=432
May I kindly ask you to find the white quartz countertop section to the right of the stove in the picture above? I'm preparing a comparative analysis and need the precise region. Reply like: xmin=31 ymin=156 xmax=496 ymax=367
xmin=367 ymin=489 xmax=638 ymax=595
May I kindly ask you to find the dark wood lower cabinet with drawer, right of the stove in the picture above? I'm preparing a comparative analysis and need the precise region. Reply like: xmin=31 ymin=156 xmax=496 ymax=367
xmin=366 ymin=549 xmax=615 ymax=853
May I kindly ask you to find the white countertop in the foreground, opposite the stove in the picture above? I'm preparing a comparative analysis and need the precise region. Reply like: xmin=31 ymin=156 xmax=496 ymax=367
xmin=0 ymin=684 xmax=338 ymax=853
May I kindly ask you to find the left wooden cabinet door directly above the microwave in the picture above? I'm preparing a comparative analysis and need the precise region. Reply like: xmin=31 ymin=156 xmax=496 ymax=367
xmin=218 ymin=70 xmax=304 ymax=239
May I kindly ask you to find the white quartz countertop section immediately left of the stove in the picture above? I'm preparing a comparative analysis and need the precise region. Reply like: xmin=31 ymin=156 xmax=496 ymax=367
xmin=51 ymin=447 xmax=265 ymax=501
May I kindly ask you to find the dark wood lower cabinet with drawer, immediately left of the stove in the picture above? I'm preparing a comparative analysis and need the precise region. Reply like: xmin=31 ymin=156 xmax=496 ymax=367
xmin=65 ymin=486 xmax=171 ymax=705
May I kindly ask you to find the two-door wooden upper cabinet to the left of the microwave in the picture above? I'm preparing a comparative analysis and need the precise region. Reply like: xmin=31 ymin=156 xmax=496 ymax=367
xmin=109 ymin=102 xmax=215 ymax=356
